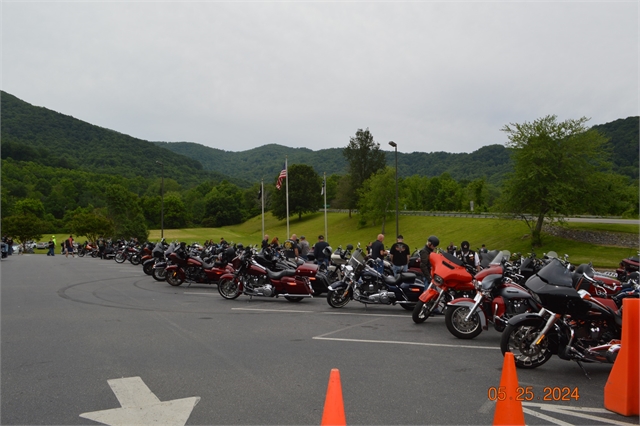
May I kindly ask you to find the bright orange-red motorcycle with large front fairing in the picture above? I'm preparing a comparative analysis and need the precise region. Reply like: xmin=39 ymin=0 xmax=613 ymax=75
xmin=411 ymin=252 xmax=478 ymax=324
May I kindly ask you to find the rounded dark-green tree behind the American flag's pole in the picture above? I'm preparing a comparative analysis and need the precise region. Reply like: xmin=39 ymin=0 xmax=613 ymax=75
xmin=271 ymin=164 xmax=322 ymax=220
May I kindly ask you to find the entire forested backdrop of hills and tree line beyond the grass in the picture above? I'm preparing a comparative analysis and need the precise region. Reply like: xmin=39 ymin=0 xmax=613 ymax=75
xmin=0 ymin=92 xmax=638 ymax=243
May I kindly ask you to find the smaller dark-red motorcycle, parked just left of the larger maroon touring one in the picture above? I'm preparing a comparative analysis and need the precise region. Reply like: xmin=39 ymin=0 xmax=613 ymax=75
xmin=165 ymin=243 xmax=239 ymax=287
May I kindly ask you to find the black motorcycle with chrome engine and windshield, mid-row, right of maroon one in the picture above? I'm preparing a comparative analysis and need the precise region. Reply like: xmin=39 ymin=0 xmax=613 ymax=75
xmin=327 ymin=248 xmax=424 ymax=311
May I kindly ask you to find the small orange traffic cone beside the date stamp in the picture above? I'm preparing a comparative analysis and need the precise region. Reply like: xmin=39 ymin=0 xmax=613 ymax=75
xmin=493 ymin=352 xmax=524 ymax=425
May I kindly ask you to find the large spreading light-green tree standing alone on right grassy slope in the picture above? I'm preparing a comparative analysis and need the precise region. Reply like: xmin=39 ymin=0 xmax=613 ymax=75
xmin=498 ymin=115 xmax=611 ymax=246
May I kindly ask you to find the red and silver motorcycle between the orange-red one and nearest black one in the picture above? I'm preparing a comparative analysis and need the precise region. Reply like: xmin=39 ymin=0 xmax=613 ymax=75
xmin=444 ymin=252 xmax=540 ymax=339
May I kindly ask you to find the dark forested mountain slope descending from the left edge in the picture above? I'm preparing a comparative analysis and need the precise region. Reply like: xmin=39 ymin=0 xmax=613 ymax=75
xmin=0 ymin=92 xmax=245 ymax=186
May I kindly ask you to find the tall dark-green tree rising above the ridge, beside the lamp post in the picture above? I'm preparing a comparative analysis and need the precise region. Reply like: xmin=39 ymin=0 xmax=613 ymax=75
xmin=342 ymin=128 xmax=386 ymax=214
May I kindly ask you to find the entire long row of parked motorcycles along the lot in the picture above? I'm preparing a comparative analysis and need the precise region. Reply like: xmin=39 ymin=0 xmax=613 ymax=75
xmin=86 ymin=241 xmax=640 ymax=374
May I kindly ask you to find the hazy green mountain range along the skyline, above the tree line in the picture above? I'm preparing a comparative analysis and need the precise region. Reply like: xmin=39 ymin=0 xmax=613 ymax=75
xmin=1 ymin=92 xmax=639 ymax=187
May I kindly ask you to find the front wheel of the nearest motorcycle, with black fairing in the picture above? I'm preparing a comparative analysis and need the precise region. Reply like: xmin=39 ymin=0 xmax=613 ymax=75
xmin=500 ymin=322 xmax=553 ymax=368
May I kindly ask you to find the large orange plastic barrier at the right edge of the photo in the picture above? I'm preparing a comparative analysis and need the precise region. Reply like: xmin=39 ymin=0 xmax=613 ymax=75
xmin=604 ymin=299 xmax=640 ymax=416
